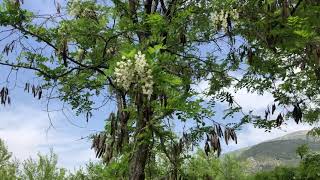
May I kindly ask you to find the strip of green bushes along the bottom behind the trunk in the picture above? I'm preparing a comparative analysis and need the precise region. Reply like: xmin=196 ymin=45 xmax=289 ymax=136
xmin=0 ymin=138 xmax=320 ymax=180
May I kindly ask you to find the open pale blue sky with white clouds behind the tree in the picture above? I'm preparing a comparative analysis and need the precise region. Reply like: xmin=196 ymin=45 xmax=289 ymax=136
xmin=0 ymin=0 xmax=311 ymax=170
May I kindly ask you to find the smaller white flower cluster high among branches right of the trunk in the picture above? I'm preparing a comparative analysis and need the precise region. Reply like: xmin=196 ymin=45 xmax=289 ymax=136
xmin=211 ymin=9 xmax=239 ymax=31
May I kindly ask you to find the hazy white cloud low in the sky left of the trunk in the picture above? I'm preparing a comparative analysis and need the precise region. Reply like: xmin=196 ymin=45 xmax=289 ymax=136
xmin=0 ymin=106 xmax=95 ymax=170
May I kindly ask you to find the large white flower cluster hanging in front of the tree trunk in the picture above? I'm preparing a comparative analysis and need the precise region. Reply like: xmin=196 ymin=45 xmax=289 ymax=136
xmin=114 ymin=51 xmax=154 ymax=99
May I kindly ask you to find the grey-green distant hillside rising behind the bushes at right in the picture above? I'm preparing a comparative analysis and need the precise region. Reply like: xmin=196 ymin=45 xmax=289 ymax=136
xmin=233 ymin=131 xmax=320 ymax=171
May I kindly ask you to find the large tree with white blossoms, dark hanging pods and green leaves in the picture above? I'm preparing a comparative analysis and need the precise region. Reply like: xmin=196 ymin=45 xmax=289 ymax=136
xmin=0 ymin=0 xmax=320 ymax=180
